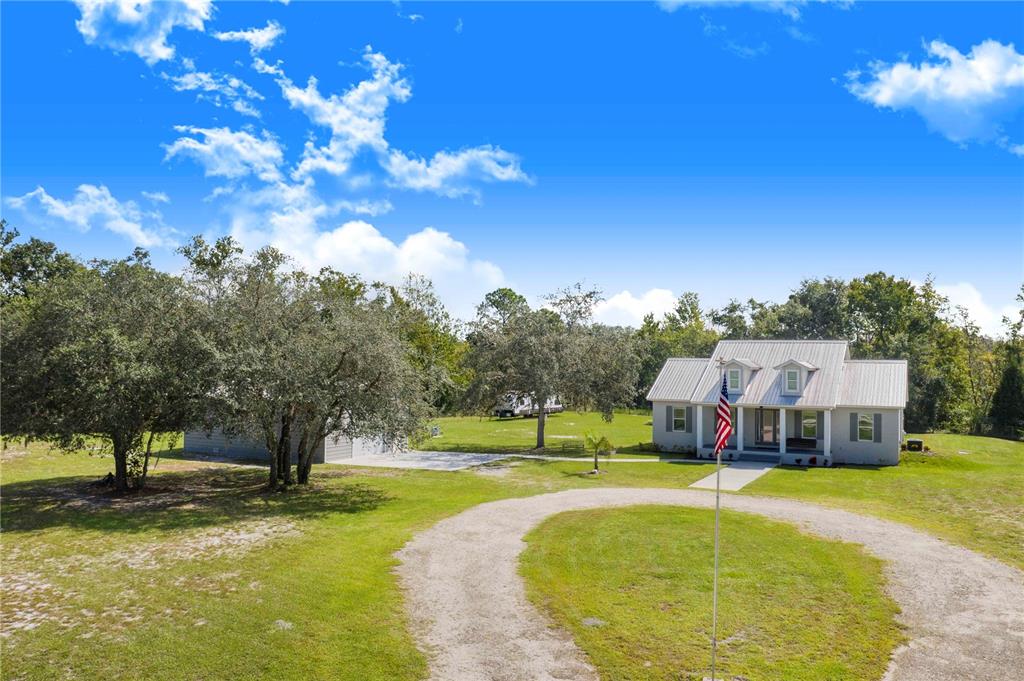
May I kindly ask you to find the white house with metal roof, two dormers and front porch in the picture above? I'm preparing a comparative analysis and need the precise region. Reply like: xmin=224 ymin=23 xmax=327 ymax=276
xmin=647 ymin=340 xmax=907 ymax=466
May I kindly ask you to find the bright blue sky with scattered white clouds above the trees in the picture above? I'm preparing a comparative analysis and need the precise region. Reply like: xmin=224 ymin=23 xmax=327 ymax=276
xmin=0 ymin=0 xmax=1024 ymax=332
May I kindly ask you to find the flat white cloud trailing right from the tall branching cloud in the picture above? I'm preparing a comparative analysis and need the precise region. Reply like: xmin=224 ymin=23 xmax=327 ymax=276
xmin=384 ymin=145 xmax=529 ymax=198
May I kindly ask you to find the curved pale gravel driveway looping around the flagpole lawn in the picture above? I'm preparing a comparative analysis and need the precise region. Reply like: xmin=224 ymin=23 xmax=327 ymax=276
xmin=397 ymin=488 xmax=1024 ymax=681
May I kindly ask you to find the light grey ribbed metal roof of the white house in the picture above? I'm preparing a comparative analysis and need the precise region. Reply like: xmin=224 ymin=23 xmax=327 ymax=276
xmin=647 ymin=340 xmax=907 ymax=409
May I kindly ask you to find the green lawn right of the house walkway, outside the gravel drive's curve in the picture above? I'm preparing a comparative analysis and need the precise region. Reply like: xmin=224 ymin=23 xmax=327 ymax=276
xmin=742 ymin=434 xmax=1024 ymax=569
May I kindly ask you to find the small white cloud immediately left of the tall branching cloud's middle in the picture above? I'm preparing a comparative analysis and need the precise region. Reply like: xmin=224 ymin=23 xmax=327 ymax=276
xmin=164 ymin=125 xmax=284 ymax=182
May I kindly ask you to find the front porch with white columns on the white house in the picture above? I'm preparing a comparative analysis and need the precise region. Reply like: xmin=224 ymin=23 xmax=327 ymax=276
xmin=694 ymin=405 xmax=831 ymax=465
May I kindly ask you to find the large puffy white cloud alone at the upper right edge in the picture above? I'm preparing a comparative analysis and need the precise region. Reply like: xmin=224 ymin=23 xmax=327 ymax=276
xmin=847 ymin=40 xmax=1024 ymax=151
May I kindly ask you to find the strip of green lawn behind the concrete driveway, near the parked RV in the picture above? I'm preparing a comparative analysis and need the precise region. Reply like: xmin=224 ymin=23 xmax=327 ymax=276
xmin=417 ymin=412 xmax=653 ymax=457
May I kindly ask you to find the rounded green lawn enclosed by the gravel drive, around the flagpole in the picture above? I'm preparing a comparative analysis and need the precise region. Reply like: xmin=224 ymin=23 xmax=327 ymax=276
xmin=520 ymin=506 xmax=902 ymax=681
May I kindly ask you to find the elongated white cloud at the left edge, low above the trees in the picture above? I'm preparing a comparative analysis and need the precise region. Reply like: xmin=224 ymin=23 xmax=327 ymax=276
xmin=7 ymin=184 xmax=170 ymax=248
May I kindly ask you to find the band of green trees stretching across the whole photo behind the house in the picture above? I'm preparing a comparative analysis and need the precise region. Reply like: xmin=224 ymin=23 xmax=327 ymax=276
xmin=0 ymin=221 xmax=1024 ymax=493
